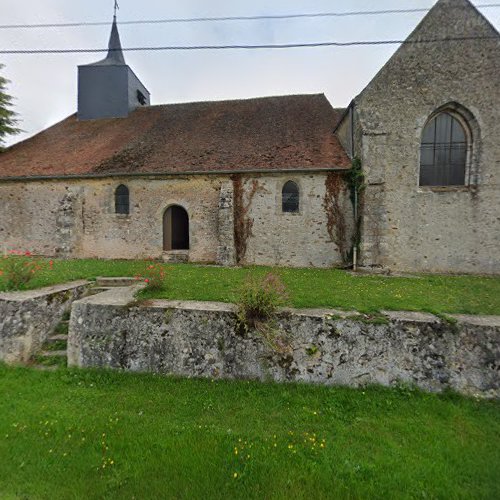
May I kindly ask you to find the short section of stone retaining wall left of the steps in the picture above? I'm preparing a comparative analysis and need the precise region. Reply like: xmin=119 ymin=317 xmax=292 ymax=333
xmin=0 ymin=281 xmax=89 ymax=363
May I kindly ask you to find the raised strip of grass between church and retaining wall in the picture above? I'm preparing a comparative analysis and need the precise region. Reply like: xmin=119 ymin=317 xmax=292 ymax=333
xmin=0 ymin=259 xmax=500 ymax=314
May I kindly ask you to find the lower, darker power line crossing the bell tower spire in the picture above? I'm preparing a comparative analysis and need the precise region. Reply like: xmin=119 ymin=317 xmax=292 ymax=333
xmin=0 ymin=35 xmax=500 ymax=55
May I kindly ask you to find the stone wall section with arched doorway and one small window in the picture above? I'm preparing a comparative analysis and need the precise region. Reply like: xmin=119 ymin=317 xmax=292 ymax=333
xmin=0 ymin=176 xmax=220 ymax=262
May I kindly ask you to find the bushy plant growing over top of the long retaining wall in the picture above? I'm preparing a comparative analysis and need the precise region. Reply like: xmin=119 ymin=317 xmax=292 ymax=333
xmin=237 ymin=273 xmax=291 ymax=354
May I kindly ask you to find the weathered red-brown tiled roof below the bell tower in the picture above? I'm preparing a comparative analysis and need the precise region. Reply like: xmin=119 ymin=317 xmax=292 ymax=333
xmin=0 ymin=94 xmax=350 ymax=178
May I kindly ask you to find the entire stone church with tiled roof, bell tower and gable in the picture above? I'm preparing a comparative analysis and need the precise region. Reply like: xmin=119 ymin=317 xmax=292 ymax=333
xmin=0 ymin=0 xmax=500 ymax=274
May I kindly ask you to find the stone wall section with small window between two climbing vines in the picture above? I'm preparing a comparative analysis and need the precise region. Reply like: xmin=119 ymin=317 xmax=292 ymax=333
xmin=243 ymin=173 xmax=353 ymax=267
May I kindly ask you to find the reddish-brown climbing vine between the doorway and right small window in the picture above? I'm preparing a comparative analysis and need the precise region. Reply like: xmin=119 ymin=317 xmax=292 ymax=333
xmin=231 ymin=174 xmax=261 ymax=264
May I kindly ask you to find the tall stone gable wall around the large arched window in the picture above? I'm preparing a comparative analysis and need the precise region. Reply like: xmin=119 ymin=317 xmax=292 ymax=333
xmin=356 ymin=0 xmax=500 ymax=273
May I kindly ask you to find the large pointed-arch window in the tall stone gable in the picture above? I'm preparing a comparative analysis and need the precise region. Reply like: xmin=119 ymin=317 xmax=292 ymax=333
xmin=420 ymin=112 xmax=470 ymax=186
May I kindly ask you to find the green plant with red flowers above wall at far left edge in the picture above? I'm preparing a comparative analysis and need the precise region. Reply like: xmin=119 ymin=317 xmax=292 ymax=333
xmin=0 ymin=250 xmax=47 ymax=291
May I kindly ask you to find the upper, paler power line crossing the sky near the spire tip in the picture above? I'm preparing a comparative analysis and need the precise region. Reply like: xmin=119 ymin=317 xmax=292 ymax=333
xmin=0 ymin=3 xmax=500 ymax=29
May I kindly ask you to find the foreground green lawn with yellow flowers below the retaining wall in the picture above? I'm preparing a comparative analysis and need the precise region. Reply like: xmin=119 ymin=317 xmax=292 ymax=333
xmin=0 ymin=365 xmax=500 ymax=500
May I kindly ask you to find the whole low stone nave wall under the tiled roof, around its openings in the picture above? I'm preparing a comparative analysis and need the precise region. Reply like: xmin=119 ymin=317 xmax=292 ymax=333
xmin=0 ymin=173 xmax=352 ymax=266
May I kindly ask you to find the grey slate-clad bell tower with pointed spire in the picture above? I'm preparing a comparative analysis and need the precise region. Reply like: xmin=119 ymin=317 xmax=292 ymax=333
xmin=78 ymin=9 xmax=150 ymax=120
